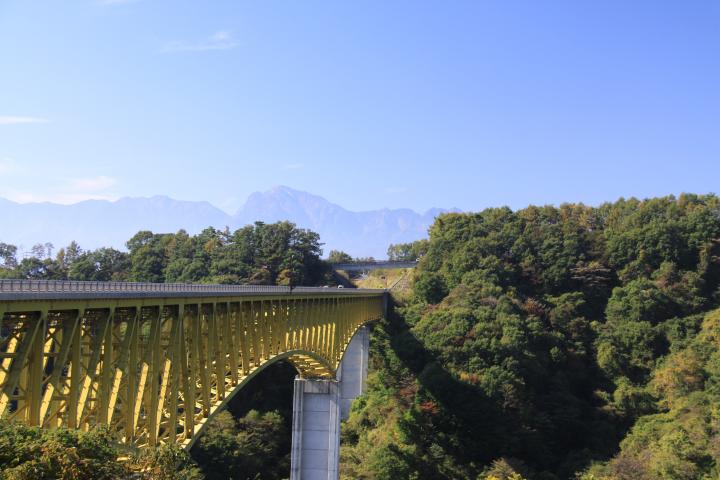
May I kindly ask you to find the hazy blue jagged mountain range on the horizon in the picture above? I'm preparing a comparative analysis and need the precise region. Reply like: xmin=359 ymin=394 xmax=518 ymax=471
xmin=0 ymin=187 xmax=446 ymax=258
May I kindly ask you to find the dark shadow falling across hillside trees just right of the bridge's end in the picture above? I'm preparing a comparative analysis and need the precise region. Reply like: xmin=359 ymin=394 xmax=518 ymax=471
xmin=383 ymin=300 xmax=517 ymax=472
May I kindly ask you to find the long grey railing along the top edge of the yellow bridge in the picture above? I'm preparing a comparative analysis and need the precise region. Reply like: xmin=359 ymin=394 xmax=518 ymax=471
xmin=0 ymin=280 xmax=382 ymax=299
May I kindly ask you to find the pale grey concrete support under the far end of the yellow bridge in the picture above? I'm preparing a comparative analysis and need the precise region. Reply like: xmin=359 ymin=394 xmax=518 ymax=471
xmin=290 ymin=327 xmax=370 ymax=480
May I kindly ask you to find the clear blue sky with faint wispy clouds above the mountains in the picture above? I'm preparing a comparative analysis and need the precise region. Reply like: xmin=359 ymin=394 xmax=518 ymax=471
xmin=0 ymin=0 xmax=720 ymax=211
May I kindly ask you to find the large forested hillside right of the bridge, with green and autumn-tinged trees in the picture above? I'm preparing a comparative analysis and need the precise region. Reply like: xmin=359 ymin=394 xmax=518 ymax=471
xmin=342 ymin=195 xmax=720 ymax=480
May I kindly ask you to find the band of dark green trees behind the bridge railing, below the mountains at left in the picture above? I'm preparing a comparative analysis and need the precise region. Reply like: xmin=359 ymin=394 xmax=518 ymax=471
xmin=0 ymin=222 xmax=331 ymax=285
